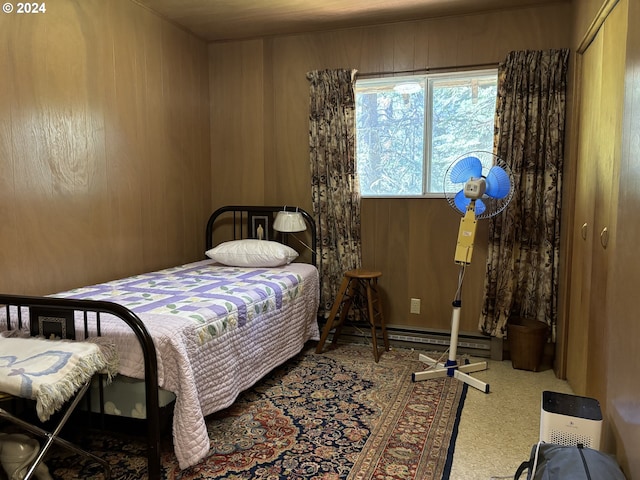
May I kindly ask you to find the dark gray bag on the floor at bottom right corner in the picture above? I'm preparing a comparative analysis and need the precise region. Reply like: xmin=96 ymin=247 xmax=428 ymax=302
xmin=513 ymin=442 xmax=625 ymax=480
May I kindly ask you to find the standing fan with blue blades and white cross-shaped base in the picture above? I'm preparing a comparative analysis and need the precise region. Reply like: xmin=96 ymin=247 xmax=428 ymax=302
xmin=413 ymin=151 xmax=514 ymax=393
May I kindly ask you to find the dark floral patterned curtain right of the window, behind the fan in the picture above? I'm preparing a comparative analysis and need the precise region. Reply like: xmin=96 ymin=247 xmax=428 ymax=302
xmin=479 ymin=50 xmax=569 ymax=342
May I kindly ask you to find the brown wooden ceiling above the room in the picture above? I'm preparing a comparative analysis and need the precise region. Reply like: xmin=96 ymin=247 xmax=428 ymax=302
xmin=134 ymin=0 xmax=570 ymax=42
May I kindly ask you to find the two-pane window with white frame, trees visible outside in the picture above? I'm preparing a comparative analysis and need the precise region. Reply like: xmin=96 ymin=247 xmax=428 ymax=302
xmin=355 ymin=70 xmax=497 ymax=197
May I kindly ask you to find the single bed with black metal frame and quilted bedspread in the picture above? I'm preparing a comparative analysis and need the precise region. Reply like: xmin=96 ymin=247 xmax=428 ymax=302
xmin=0 ymin=206 xmax=319 ymax=478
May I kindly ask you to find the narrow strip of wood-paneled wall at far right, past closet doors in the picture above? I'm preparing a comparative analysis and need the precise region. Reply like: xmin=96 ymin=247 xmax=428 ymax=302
xmin=606 ymin=1 xmax=640 ymax=472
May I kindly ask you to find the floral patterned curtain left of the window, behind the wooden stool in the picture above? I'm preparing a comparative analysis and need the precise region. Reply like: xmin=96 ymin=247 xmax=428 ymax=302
xmin=307 ymin=69 xmax=361 ymax=316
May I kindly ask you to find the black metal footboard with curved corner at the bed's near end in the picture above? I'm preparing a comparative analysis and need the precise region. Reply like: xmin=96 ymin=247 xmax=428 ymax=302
xmin=0 ymin=294 xmax=161 ymax=479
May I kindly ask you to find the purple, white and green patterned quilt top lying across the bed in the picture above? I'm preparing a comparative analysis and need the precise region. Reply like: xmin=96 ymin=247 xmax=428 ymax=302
xmin=60 ymin=263 xmax=302 ymax=345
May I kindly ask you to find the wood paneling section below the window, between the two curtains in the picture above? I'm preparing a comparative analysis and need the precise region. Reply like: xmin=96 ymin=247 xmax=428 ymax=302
xmin=362 ymin=199 xmax=487 ymax=332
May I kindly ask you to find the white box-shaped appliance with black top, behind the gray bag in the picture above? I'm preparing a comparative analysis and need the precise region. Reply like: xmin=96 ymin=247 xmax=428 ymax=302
xmin=540 ymin=391 xmax=602 ymax=450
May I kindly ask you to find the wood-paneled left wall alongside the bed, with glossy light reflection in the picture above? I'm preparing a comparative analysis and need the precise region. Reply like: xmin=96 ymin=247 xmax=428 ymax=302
xmin=0 ymin=0 xmax=211 ymax=294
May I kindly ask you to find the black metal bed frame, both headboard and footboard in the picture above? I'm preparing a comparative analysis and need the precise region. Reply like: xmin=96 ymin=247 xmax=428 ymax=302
xmin=0 ymin=205 xmax=317 ymax=480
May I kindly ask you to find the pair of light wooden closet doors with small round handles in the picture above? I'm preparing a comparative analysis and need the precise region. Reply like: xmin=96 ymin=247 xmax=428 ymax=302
xmin=567 ymin=0 xmax=627 ymax=408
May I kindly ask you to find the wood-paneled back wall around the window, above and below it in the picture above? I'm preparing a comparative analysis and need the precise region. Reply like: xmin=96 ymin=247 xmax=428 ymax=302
xmin=209 ymin=2 xmax=572 ymax=333
